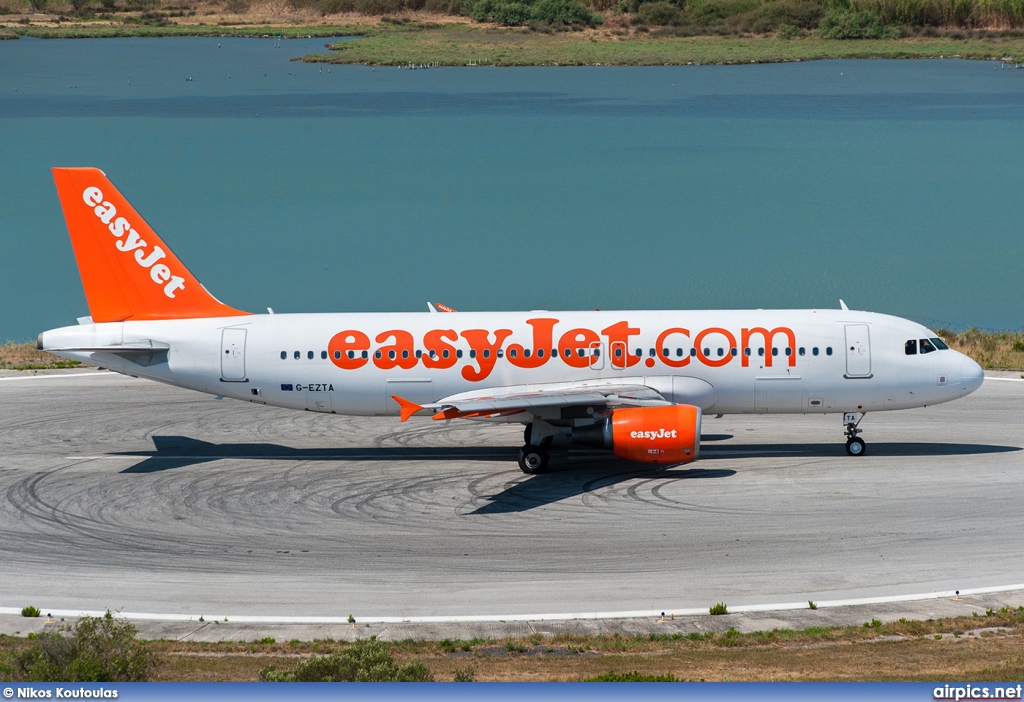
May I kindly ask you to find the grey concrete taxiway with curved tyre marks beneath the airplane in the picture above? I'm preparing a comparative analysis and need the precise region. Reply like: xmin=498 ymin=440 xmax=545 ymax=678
xmin=0 ymin=371 xmax=1024 ymax=628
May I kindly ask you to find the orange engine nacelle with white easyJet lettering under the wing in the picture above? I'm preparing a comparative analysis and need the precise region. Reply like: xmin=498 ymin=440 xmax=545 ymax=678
xmin=572 ymin=404 xmax=701 ymax=464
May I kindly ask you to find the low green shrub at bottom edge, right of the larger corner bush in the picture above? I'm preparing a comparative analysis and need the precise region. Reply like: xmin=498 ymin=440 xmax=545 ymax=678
xmin=259 ymin=637 xmax=434 ymax=683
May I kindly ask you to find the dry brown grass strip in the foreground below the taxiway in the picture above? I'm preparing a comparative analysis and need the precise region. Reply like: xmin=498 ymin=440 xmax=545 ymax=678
xmin=6 ymin=608 xmax=1024 ymax=682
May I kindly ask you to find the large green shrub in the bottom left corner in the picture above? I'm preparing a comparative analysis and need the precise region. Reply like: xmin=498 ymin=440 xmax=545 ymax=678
xmin=10 ymin=611 xmax=157 ymax=683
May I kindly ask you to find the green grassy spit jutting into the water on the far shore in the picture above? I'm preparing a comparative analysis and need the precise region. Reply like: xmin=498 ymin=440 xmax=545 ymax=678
xmin=302 ymin=25 xmax=1024 ymax=65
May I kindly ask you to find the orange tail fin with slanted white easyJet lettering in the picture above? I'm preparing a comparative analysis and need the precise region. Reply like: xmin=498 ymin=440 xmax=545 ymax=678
xmin=53 ymin=168 xmax=249 ymax=322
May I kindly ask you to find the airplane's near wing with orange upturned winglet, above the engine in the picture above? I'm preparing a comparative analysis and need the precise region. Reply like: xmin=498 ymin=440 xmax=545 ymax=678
xmin=392 ymin=385 xmax=673 ymax=422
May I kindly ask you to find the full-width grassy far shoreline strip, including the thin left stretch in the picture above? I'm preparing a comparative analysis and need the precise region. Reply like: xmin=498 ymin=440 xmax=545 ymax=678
xmin=0 ymin=15 xmax=1024 ymax=66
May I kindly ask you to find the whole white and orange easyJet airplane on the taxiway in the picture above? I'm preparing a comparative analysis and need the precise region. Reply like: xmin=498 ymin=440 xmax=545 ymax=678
xmin=39 ymin=168 xmax=983 ymax=473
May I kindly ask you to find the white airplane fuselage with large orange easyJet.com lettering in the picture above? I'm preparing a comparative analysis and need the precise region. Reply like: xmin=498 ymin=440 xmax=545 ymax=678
xmin=40 ymin=310 xmax=982 ymax=421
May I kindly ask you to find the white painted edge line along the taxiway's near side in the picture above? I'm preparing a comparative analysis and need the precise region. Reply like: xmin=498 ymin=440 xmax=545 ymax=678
xmin=0 ymin=583 xmax=1024 ymax=624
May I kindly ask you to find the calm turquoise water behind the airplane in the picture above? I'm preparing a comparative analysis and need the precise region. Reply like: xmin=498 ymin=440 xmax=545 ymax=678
xmin=0 ymin=38 xmax=1024 ymax=339
